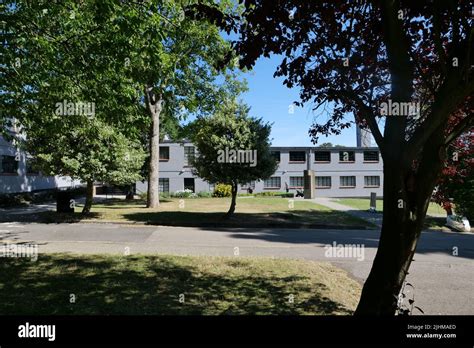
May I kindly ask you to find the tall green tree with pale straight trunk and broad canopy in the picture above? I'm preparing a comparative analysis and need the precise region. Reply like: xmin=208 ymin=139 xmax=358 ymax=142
xmin=2 ymin=0 xmax=243 ymax=207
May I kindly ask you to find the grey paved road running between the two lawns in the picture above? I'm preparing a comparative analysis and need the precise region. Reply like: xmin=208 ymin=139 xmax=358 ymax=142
xmin=0 ymin=223 xmax=474 ymax=314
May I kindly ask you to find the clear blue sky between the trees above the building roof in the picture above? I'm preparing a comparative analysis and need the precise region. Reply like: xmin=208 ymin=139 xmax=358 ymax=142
xmin=241 ymin=56 xmax=356 ymax=146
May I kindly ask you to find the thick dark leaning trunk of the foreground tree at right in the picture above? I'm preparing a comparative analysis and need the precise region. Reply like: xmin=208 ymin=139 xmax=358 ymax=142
xmin=355 ymin=130 xmax=445 ymax=315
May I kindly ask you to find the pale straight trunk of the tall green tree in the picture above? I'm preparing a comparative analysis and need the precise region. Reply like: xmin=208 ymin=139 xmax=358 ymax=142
xmin=145 ymin=86 xmax=163 ymax=208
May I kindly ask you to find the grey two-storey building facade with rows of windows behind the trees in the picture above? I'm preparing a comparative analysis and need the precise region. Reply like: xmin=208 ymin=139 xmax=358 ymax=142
xmin=136 ymin=141 xmax=383 ymax=197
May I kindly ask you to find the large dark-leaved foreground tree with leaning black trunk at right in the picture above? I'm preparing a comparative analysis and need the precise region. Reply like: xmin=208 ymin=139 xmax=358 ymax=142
xmin=227 ymin=0 xmax=474 ymax=315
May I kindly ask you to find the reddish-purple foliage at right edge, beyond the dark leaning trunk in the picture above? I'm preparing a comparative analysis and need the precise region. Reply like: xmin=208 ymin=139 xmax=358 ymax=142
xmin=433 ymin=131 xmax=474 ymax=221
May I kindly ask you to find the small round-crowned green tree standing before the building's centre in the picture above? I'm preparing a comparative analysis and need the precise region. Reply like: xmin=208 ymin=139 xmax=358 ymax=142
xmin=190 ymin=102 xmax=277 ymax=217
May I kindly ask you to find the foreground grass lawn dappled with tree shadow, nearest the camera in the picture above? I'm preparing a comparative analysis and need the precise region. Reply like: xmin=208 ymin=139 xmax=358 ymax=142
xmin=0 ymin=254 xmax=361 ymax=315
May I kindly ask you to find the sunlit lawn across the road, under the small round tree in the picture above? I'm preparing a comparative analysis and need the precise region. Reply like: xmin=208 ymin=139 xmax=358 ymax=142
xmin=22 ymin=197 xmax=372 ymax=228
